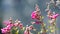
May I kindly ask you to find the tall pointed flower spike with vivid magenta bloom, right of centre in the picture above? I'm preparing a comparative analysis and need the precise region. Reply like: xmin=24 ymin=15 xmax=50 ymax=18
xmin=31 ymin=4 xmax=42 ymax=24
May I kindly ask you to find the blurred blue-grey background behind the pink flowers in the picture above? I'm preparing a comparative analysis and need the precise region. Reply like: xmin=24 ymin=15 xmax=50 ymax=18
xmin=0 ymin=0 xmax=60 ymax=34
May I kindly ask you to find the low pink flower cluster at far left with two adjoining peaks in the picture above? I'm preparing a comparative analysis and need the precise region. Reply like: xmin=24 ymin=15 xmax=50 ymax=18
xmin=1 ymin=18 xmax=23 ymax=33
